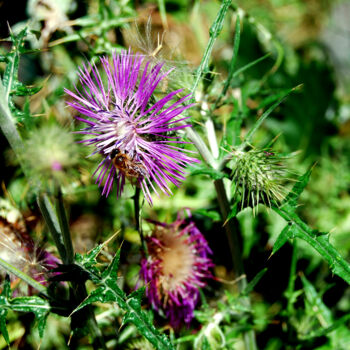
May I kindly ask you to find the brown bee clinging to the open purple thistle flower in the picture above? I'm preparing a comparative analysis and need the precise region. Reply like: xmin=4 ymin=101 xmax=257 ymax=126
xmin=110 ymin=148 xmax=147 ymax=180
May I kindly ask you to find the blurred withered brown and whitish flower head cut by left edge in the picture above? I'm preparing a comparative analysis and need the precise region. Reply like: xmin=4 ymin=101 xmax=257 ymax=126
xmin=0 ymin=198 xmax=59 ymax=292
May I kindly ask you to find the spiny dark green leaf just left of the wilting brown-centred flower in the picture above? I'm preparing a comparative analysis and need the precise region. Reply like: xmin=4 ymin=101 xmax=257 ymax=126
xmin=74 ymin=247 xmax=173 ymax=350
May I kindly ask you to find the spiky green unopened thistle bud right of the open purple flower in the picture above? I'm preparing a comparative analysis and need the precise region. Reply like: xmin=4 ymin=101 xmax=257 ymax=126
xmin=232 ymin=148 xmax=287 ymax=210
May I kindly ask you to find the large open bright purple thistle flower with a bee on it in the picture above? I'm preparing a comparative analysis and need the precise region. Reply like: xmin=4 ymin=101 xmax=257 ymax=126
xmin=65 ymin=50 xmax=198 ymax=204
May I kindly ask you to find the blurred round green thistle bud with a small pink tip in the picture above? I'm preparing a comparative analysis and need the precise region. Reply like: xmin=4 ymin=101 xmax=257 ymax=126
xmin=23 ymin=124 xmax=79 ymax=182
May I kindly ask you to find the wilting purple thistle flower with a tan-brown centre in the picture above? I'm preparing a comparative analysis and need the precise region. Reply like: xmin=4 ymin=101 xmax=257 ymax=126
xmin=140 ymin=211 xmax=213 ymax=328
